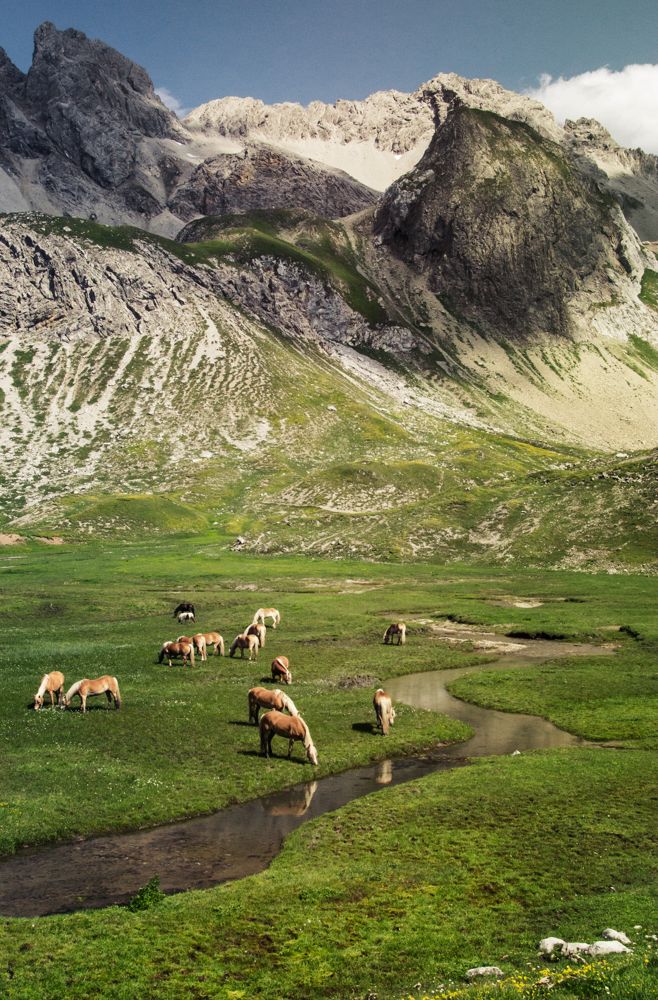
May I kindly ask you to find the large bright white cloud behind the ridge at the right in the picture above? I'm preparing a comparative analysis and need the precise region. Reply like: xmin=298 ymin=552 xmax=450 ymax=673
xmin=527 ymin=63 xmax=658 ymax=153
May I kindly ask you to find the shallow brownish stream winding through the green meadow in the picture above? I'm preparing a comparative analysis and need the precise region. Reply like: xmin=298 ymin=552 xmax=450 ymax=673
xmin=0 ymin=628 xmax=610 ymax=917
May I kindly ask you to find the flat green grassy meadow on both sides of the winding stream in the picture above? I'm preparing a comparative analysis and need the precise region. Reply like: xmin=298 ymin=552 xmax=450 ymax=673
xmin=0 ymin=538 xmax=658 ymax=1000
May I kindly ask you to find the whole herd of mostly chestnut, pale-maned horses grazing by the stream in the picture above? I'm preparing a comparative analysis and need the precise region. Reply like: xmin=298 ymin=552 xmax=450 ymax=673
xmin=33 ymin=602 xmax=406 ymax=765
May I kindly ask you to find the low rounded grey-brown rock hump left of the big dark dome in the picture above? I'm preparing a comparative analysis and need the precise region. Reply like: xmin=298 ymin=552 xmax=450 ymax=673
xmin=169 ymin=146 xmax=376 ymax=219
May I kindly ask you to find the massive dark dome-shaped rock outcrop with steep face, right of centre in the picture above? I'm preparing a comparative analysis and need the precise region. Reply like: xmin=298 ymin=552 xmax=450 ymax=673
xmin=375 ymin=99 xmax=642 ymax=338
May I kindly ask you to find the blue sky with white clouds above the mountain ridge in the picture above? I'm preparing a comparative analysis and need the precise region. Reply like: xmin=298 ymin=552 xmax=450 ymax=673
xmin=0 ymin=0 xmax=658 ymax=152
